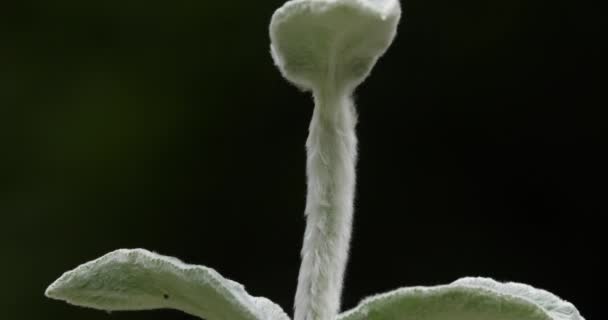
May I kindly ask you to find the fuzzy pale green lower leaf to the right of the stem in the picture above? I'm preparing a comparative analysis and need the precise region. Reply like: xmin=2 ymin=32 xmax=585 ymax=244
xmin=338 ymin=278 xmax=584 ymax=320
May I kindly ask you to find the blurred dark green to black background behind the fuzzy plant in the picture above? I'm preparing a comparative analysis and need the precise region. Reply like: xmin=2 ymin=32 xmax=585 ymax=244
xmin=0 ymin=0 xmax=608 ymax=320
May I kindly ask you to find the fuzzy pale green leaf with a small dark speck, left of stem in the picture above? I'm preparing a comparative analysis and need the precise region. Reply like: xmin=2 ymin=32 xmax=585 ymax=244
xmin=46 ymin=249 xmax=289 ymax=320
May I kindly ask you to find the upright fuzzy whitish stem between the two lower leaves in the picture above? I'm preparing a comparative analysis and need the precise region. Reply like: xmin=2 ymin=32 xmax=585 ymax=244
xmin=294 ymin=88 xmax=357 ymax=320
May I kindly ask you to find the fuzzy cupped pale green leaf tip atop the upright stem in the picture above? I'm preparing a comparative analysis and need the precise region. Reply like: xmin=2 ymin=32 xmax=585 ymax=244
xmin=270 ymin=0 xmax=401 ymax=90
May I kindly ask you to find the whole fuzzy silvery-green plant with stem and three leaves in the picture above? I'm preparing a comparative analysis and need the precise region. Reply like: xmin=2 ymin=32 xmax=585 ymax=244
xmin=46 ymin=0 xmax=584 ymax=320
